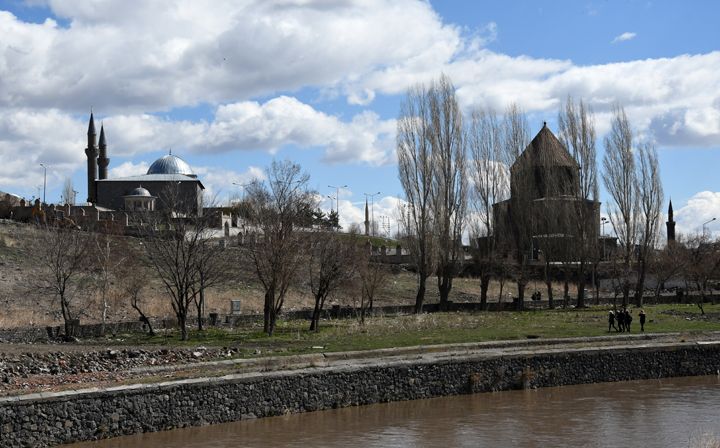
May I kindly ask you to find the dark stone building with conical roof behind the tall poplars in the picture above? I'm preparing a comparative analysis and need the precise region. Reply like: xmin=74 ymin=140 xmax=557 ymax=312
xmin=493 ymin=124 xmax=600 ymax=261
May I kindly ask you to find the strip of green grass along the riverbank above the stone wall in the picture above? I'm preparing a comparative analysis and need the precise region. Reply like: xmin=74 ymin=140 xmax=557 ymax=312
xmin=107 ymin=304 xmax=720 ymax=357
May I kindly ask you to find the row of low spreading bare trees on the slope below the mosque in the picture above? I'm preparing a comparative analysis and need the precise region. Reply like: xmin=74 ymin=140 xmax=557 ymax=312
xmin=37 ymin=161 xmax=387 ymax=340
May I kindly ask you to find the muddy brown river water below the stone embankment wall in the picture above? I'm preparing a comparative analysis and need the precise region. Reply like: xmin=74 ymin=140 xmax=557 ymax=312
xmin=68 ymin=376 xmax=720 ymax=448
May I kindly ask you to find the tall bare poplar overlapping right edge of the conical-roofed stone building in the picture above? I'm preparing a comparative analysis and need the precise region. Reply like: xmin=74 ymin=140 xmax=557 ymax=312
xmin=558 ymin=97 xmax=600 ymax=308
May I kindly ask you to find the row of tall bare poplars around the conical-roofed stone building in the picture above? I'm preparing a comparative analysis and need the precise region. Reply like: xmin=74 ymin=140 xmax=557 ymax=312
xmin=397 ymin=75 xmax=663 ymax=312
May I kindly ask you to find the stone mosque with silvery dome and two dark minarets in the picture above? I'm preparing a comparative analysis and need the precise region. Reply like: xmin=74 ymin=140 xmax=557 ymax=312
xmin=85 ymin=113 xmax=205 ymax=214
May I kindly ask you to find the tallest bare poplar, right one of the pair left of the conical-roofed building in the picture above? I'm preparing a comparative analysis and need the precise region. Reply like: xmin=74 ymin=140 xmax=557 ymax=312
xmin=429 ymin=75 xmax=468 ymax=309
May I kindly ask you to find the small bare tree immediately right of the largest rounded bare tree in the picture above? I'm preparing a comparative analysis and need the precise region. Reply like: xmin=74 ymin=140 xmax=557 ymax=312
xmin=306 ymin=232 xmax=357 ymax=331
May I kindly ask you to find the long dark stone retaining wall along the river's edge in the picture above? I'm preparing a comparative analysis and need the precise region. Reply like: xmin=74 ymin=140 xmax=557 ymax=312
xmin=0 ymin=343 xmax=720 ymax=447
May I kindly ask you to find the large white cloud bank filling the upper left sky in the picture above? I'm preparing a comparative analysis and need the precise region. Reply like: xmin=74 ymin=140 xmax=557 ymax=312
xmin=0 ymin=0 xmax=461 ymax=111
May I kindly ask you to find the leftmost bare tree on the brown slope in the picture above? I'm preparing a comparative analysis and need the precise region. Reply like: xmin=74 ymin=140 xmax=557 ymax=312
xmin=35 ymin=225 xmax=91 ymax=339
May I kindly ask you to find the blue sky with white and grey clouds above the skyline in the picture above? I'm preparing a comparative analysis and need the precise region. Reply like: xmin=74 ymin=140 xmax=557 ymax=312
xmin=0 ymin=0 xmax=720 ymax=235
